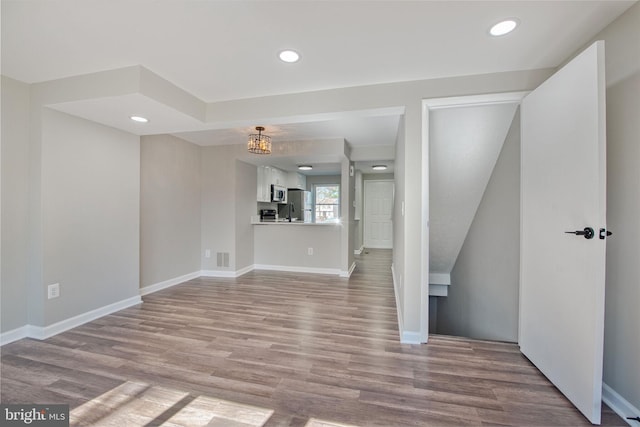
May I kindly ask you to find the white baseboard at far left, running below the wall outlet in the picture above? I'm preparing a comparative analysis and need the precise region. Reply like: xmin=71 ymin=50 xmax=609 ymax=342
xmin=1 ymin=296 xmax=142 ymax=345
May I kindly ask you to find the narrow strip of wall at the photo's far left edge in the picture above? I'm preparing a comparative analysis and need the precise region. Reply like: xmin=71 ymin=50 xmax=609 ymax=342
xmin=0 ymin=76 xmax=29 ymax=332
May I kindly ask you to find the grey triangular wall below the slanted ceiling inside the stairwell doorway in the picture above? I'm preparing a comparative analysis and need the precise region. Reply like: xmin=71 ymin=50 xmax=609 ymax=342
xmin=433 ymin=112 xmax=520 ymax=342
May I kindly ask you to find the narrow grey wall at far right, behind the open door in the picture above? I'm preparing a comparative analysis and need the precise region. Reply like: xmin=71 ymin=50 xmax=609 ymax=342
xmin=595 ymin=3 xmax=640 ymax=416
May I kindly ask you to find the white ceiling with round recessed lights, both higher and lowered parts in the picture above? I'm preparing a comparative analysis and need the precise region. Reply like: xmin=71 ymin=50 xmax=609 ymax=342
xmin=1 ymin=0 xmax=634 ymax=172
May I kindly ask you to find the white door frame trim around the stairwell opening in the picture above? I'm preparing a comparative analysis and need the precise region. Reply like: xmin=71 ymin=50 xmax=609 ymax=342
xmin=420 ymin=91 xmax=531 ymax=343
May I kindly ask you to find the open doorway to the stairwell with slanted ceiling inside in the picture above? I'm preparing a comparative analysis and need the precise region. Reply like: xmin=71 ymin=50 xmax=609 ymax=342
xmin=429 ymin=95 xmax=520 ymax=342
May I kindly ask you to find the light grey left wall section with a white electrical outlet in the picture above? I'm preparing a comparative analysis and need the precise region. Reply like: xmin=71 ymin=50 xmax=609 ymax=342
xmin=38 ymin=108 xmax=140 ymax=326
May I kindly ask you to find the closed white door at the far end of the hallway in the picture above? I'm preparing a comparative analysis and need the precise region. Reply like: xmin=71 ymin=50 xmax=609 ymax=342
xmin=363 ymin=181 xmax=393 ymax=249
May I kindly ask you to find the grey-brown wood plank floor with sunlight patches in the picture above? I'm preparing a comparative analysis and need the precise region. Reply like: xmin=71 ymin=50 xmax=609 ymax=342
xmin=0 ymin=250 xmax=626 ymax=427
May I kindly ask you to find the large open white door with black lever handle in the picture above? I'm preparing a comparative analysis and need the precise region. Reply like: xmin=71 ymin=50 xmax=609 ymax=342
xmin=519 ymin=42 xmax=606 ymax=424
